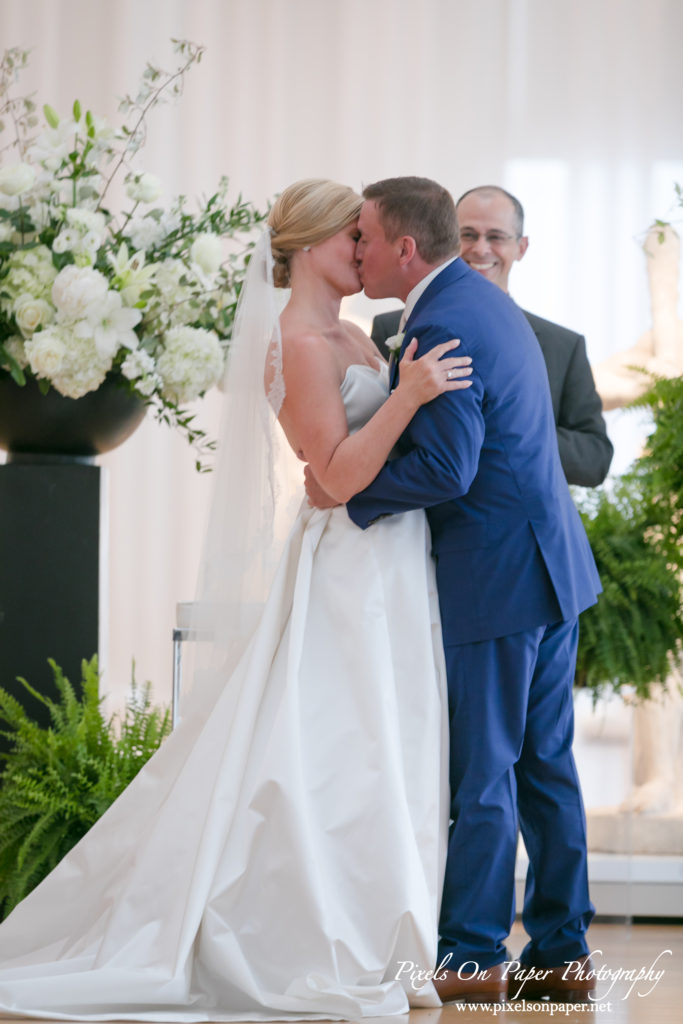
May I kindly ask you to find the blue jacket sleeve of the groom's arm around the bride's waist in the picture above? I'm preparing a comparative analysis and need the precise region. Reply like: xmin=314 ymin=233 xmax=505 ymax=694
xmin=347 ymin=328 xmax=484 ymax=529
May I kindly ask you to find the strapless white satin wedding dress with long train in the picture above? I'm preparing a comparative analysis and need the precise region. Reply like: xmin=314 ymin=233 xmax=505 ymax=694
xmin=0 ymin=366 xmax=447 ymax=1021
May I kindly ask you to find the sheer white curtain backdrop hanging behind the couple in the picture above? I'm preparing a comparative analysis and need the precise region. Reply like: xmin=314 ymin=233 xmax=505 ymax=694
xmin=0 ymin=0 xmax=683 ymax=707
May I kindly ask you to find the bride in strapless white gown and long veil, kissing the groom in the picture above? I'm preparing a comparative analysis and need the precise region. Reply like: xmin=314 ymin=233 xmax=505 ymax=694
xmin=0 ymin=179 xmax=469 ymax=1021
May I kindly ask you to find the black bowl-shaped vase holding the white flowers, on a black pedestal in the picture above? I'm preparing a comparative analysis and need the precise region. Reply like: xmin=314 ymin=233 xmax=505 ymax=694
xmin=0 ymin=372 xmax=145 ymax=462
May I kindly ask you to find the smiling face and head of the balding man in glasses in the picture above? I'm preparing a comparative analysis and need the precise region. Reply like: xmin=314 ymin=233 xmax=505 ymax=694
xmin=458 ymin=193 xmax=528 ymax=292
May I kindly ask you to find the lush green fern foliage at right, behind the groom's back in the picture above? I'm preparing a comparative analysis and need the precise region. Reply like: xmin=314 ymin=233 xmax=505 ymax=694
xmin=577 ymin=377 xmax=683 ymax=698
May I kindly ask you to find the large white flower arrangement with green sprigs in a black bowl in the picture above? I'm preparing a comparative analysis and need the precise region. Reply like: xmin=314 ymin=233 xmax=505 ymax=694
xmin=0 ymin=41 xmax=264 ymax=468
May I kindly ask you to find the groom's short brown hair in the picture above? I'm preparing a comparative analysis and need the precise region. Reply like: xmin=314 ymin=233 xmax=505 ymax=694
xmin=362 ymin=177 xmax=459 ymax=263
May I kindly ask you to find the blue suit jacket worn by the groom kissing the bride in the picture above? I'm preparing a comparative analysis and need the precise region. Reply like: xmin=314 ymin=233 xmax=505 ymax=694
xmin=347 ymin=259 xmax=600 ymax=645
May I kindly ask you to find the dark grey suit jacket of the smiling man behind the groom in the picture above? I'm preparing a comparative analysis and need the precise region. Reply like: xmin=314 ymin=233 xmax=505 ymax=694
xmin=372 ymin=309 xmax=614 ymax=487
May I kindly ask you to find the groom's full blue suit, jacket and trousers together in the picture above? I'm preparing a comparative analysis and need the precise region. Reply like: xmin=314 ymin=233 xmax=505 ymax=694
xmin=348 ymin=259 xmax=600 ymax=970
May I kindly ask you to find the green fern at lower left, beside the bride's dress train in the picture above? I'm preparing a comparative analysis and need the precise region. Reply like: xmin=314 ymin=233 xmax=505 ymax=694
xmin=0 ymin=656 xmax=170 ymax=918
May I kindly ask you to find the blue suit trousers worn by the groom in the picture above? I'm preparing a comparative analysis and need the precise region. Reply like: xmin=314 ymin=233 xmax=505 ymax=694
xmin=439 ymin=618 xmax=594 ymax=971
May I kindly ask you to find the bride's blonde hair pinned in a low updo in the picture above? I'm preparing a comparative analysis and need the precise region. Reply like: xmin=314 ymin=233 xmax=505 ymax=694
xmin=267 ymin=178 xmax=362 ymax=288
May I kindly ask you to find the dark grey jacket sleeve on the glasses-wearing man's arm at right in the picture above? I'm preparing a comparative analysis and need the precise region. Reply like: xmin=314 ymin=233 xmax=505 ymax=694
xmin=557 ymin=335 xmax=614 ymax=487
